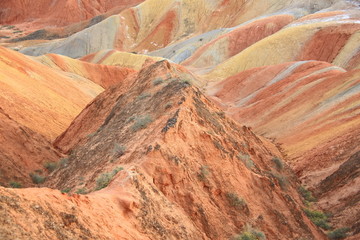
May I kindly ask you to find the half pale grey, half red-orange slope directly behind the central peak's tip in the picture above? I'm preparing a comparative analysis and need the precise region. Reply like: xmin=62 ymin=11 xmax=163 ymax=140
xmin=149 ymin=13 xmax=298 ymax=68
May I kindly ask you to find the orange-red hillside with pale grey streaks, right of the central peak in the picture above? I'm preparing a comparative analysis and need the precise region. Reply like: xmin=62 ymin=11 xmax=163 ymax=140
xmin=208 ymin=61 xmax=360 ymax=176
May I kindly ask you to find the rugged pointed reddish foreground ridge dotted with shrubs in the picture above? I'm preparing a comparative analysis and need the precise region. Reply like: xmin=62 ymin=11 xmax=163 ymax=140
xmin=1 ymin=61 xmax=323 ymax=239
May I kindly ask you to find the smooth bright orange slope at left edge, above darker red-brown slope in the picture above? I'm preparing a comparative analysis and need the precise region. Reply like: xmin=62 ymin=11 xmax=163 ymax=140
xmin=0 ymin=47 xmax=103 ymax=139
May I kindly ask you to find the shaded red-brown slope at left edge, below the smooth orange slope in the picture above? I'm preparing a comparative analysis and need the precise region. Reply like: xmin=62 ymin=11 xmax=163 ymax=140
xmin=0 ymin=106 xmax=61 ymax=188
